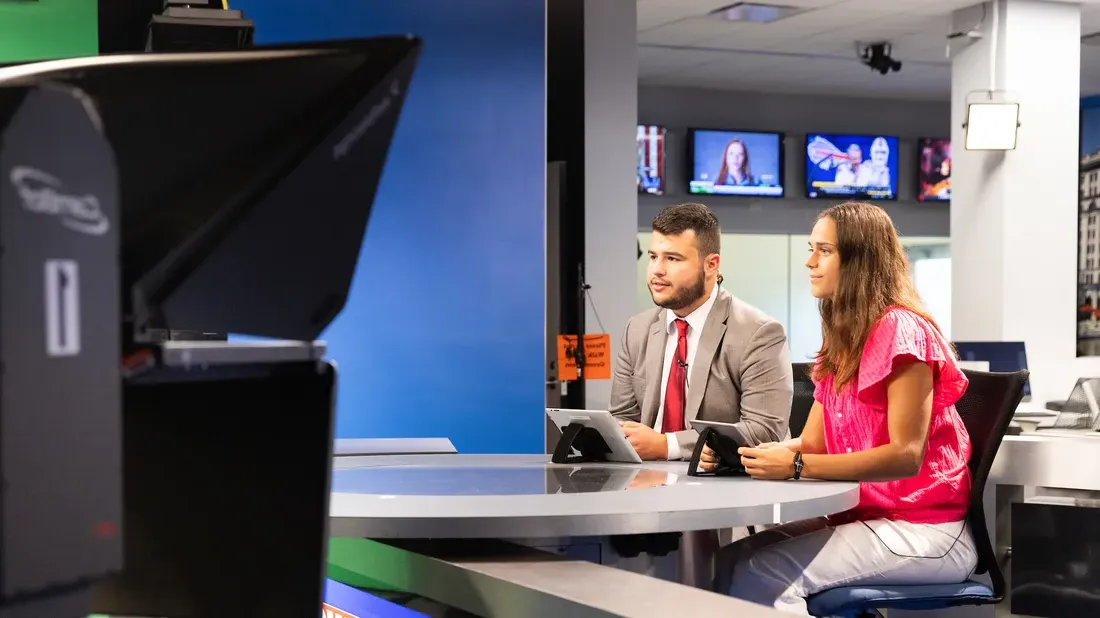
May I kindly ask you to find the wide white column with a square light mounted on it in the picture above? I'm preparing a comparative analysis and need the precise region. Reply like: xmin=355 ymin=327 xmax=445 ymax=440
xmin=950 ymin=0 xmax=1086 ymax=405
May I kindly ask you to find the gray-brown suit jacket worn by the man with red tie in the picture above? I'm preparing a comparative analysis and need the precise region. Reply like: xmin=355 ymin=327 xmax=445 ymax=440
xmin=608 ymin=289 xmax=794 ymax=459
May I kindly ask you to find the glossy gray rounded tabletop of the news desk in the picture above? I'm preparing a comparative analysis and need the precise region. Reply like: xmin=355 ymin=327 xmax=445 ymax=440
xmin=329 ymin=454 xmax=859 ymax=539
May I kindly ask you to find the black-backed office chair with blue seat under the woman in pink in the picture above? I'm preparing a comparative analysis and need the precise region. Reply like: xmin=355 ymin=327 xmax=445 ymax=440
xmin=806 ymin=369 xmax=1029 ymax=618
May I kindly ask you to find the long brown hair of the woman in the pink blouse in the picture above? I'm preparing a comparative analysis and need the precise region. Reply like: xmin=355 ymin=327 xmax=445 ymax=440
xmin=814 ymin=201 xmax=939 ymax=391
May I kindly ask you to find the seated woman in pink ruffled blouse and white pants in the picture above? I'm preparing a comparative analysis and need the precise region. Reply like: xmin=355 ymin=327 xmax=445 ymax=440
xmin=718 ymin=202 xmax=977 ymax=616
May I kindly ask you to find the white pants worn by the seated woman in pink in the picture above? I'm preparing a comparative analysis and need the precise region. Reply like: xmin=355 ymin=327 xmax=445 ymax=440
xmin=715 ymin=518 xmax=978 ymax=616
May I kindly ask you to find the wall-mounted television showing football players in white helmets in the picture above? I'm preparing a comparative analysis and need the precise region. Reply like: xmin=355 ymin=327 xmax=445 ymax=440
xmin=806 ymin=133 xmax=898 ymax=200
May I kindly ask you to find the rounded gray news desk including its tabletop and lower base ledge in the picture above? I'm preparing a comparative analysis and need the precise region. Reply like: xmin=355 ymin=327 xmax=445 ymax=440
xmin=329 ymin=454 xmax=859 ymax=618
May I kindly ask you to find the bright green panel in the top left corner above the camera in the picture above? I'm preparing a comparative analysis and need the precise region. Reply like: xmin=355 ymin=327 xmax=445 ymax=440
xmin=0 ymin=0 xmax=99 ymax=64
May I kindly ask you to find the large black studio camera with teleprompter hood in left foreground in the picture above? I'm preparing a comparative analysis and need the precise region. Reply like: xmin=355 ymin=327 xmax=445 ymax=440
xmin=0 ymin=36 xmax=420 ymax=618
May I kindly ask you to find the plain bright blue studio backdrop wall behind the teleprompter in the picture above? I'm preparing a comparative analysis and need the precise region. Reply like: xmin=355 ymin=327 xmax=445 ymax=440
xmin=230 ymin=0 xmax=546 ymax=453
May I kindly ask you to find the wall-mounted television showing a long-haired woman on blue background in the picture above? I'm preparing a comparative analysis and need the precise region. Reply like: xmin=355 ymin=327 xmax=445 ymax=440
xmin=688 ymin=129 xmax=783 ymax=197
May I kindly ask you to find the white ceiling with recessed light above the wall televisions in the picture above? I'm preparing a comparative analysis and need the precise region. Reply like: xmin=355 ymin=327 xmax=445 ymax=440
xmin=638 ymin=0 xmax=1100 ymax=100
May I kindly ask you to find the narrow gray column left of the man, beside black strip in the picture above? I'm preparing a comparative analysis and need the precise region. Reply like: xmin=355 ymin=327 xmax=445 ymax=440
xmin=584 ymin=0 xmax=638 ymax=410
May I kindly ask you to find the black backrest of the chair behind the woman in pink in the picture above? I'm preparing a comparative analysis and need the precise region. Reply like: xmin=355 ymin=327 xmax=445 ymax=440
xmin=955 ymin=369 xmax=1029 ymax=602
